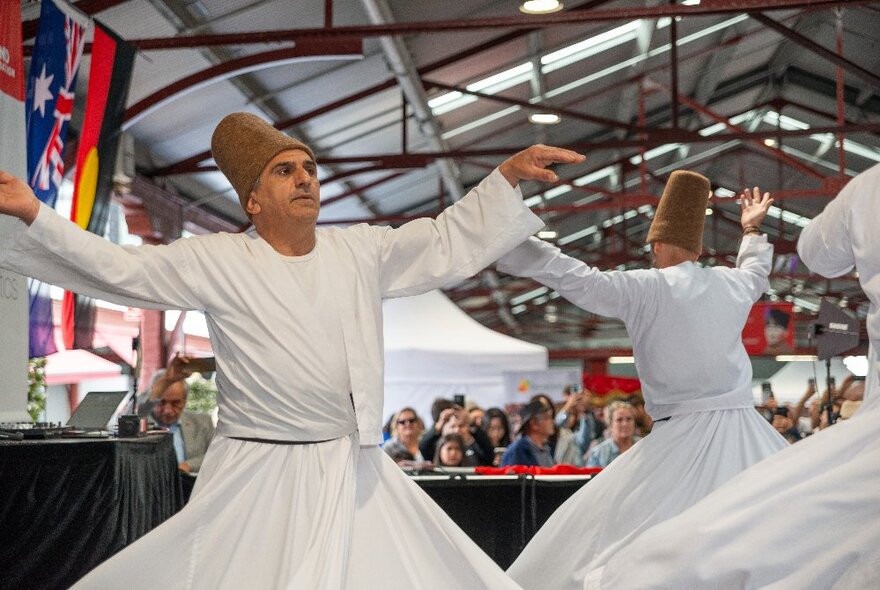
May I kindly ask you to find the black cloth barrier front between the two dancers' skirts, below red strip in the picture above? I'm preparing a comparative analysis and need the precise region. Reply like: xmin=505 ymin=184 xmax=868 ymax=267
xmin=413 ymin=475 xmax=590 ymax=569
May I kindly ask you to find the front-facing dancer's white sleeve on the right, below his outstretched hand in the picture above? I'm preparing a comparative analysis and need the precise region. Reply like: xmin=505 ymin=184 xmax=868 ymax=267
xmin=379 ymin=169 xmax=544 ymax=298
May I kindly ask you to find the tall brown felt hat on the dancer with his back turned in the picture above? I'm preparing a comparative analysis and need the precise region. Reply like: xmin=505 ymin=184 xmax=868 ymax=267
xmin=648 ymin=170 xmax=711 ymax=254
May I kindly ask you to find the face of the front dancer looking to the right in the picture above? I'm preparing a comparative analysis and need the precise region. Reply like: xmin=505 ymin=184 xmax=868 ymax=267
xmin=248 ymin=150 xmax=321 ymax=221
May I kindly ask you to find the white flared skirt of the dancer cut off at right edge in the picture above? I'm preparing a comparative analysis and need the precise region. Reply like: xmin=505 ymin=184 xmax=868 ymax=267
xmin=586 ymin=400 xmax=880 ymax=590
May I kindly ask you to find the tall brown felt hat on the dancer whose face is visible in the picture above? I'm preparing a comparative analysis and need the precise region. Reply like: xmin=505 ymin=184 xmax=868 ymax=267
xmin=211 ymin=113 xmax=315 ymax=211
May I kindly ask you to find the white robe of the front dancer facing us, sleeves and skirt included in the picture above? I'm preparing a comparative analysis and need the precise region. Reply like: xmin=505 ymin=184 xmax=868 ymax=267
xmin=0 ymin=170 xmax=543 ymax=589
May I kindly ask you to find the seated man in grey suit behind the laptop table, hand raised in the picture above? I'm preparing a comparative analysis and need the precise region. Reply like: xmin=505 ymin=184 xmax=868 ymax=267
xmin=138 ymin=356 xmax=214 ymax=473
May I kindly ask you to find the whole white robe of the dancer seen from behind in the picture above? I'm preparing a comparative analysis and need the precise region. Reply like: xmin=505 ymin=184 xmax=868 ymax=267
xmin=498 ymin=236 xmax=788 ymax=590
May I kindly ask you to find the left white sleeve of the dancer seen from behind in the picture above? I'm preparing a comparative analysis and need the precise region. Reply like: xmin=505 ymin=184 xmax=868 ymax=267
xmin=498 ymin=238 xmax=650 ymax=321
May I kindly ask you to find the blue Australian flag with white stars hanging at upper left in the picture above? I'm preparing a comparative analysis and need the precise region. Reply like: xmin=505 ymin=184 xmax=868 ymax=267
xmin=25 ymin=0 xmax=88 ymax=358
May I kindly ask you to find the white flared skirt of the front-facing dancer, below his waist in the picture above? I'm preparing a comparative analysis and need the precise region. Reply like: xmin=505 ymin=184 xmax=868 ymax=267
xmin=75 ymin=435 xmax=519 ymax=590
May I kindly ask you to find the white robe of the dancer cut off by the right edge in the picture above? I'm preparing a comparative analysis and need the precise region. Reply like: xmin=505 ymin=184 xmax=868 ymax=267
xmin=586 ymin=165 xmax=880 ymax=590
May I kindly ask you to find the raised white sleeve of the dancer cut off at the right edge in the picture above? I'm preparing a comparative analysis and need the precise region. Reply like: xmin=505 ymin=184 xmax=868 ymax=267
xmin=797 ymin=177 xmax=862 ymax=278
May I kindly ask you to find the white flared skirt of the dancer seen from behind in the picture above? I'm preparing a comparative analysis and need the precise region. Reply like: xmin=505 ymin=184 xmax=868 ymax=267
xmin=508 ymin=408 xmax=788 ymax=590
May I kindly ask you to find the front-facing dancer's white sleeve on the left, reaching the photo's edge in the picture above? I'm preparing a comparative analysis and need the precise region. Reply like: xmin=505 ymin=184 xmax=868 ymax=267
xmin=0 ymin=205 xmax=203 ymax=310
